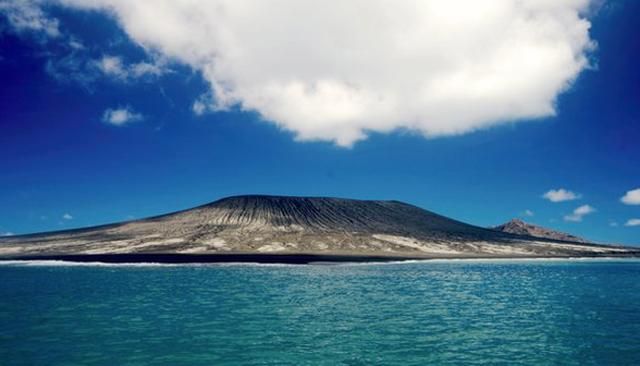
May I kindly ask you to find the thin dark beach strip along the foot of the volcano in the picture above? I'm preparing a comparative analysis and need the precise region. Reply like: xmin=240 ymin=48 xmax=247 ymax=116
xmin=0 ymin=251 xmax=640 ymax=265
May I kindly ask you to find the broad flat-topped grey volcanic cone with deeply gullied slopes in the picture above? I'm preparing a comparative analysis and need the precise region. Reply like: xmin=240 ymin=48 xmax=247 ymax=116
xmin=0 ymin=195 xmax=638 ymax=259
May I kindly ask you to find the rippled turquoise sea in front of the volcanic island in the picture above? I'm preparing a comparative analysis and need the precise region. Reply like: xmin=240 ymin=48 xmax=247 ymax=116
xmin=0 ymin=260 xmax=640 ymax=365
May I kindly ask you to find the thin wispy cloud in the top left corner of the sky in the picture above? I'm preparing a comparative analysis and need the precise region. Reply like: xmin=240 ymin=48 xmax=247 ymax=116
xmin=0 ymin=0 xmax=60 ymax=38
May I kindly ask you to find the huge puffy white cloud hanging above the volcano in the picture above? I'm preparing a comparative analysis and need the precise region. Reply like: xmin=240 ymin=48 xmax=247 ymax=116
xmin=58 ymin=0 xmax=594 ymax=146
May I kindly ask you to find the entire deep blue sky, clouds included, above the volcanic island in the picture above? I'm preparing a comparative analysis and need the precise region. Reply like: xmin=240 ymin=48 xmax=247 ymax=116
xmin=0 ymin=0 xmax=640 ymax=245
